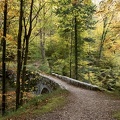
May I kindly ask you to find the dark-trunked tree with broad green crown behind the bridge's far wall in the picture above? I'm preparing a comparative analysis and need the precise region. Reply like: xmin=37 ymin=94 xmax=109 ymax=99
xmin=52 ymin=0 xmax=95 ymax=79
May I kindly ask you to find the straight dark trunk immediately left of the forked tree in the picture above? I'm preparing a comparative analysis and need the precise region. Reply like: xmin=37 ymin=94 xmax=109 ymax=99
xmin=16 ymin=0 xmax=23 ymax=109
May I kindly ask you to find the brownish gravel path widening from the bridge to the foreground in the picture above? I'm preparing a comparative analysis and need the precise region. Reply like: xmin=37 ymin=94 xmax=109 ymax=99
xmin=34 ymin=76 xmax=120 ymax=120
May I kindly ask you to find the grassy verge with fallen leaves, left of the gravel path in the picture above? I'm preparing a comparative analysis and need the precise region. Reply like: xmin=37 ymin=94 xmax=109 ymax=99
xmin=0 ymin=89 xmax=69 ymax=120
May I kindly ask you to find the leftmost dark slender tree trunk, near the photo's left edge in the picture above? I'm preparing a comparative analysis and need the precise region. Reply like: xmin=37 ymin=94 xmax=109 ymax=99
xmin=2 ymin=0 xmax=8 ymax=115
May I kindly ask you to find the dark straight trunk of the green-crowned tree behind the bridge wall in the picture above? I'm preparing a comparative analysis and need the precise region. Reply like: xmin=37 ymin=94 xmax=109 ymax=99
xmin=74 ymin=16 xmax=78 ymax=80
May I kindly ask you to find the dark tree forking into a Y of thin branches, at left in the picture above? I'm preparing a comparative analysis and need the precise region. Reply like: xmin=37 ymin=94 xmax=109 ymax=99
xmin=20 ymin=0 xmax=42 ymax=105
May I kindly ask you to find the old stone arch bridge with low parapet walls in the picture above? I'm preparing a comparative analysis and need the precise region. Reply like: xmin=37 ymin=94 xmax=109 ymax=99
xmin=34 ymin=73 xmax=100 ymax=95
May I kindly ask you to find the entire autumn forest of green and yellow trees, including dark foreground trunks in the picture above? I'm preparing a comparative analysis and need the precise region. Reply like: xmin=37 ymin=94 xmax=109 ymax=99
xmin=0 ymin=0 xmax=120 ymax=115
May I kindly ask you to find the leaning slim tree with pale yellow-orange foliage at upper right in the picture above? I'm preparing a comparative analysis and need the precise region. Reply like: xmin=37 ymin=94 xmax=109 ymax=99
xmin=97 ymin=0 xmax=120 ymax=60
